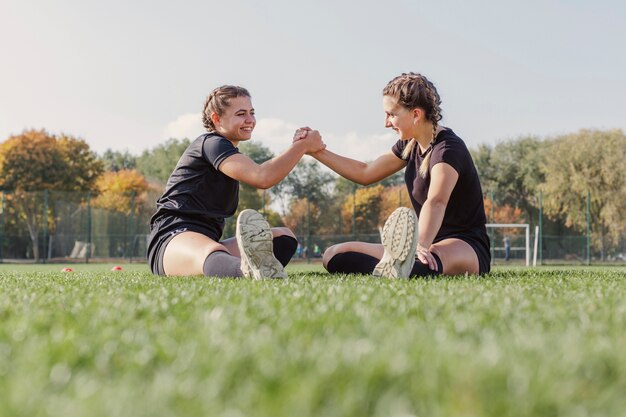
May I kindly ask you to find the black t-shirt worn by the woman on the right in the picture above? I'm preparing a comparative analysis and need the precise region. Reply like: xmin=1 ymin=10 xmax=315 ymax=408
xmin=392 ymin=129 xmax=489 ymax=248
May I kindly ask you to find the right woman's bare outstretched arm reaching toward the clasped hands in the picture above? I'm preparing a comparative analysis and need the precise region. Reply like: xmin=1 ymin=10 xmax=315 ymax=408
xmin=311 ymin=149 xmax=406 ymax=185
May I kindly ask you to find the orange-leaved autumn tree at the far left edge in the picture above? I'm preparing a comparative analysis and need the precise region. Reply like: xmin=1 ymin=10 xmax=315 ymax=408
xmin=0 ymin=130 xmax=103 ymax=260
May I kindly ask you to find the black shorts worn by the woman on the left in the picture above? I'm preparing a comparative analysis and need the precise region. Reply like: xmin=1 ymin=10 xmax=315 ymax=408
xmin=148 ymin=216 xmax=224 ymax=275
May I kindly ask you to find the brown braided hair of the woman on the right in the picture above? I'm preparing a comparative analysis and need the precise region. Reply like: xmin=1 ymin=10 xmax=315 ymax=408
xmin=383 ymin=72 xmax=442 ymax=178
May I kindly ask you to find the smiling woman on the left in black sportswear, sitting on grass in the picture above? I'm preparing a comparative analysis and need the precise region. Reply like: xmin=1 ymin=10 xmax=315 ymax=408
xmin=148 ymin=85 xmax=325 ymax=278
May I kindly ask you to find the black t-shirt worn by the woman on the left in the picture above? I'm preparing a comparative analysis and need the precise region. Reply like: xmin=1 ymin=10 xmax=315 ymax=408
xmin=150 ymin=133 xmax=239 ymax=224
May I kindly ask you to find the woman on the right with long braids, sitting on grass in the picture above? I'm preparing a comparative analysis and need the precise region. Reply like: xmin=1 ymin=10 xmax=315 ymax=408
xmin=294 ymin=73 xmax=491 ymax=278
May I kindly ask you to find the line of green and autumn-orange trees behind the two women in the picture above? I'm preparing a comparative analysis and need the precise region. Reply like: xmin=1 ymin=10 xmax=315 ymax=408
xmin=0 ymin=130 xmax=626 ymax=257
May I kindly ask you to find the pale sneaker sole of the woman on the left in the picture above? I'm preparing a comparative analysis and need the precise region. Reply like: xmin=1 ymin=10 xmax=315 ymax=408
xmin=236 ymin=209 xmax=287 ymax=279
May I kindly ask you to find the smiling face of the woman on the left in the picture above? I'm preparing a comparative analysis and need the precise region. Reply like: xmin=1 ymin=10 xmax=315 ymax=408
xmin=211 ymin=96 xmax=256 ymax=145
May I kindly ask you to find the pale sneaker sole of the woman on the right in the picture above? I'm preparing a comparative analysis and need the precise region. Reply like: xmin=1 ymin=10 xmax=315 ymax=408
xmin=373 ymin=207 xmax=417 ymax=278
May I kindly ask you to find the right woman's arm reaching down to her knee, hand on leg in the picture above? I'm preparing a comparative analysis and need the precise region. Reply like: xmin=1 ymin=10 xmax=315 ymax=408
xmin=417 ymin=162 xmax=459 ymax=270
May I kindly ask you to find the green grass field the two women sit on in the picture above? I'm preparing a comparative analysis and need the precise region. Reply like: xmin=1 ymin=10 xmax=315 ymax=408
xmin=0 ymin=264 xmax=626 ymax=417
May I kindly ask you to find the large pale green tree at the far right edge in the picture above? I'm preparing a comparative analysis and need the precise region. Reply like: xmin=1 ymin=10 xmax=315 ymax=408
xmin=542 ymin=130 xmax=626 ymax=258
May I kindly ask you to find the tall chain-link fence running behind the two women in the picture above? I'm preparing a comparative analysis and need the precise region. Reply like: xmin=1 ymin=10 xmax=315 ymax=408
xmin=0 ymin=184 xmax=626 ymax=264
